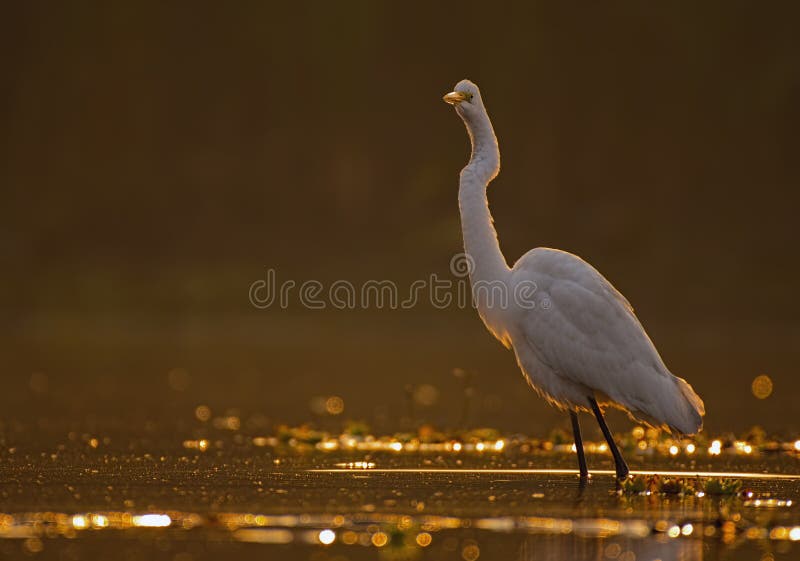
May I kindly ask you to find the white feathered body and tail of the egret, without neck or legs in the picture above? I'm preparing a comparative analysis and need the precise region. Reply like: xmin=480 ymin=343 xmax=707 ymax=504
xmin=511 ymin=248 xmax=704 ymax=434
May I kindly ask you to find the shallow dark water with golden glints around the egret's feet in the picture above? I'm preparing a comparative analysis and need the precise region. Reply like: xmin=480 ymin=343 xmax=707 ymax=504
xmin=0 ymin=435 xmax=800 ymax=561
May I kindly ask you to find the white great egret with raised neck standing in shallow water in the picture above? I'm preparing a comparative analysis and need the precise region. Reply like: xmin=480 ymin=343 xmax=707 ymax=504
xmin=444 ymin=80 xmax=705 ymax=481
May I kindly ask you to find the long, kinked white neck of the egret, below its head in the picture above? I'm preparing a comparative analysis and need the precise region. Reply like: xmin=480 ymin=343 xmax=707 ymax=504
xmin=458 ymin=107 xmax=510 ymax=288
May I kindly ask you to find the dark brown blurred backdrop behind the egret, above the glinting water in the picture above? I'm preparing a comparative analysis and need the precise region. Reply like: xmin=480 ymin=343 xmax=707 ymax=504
xmin=0 ymin=1 xmax=800 ymax=435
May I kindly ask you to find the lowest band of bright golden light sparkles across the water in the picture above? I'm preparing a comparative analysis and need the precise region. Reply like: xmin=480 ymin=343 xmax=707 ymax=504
xmin=0 ymin=508 xmax=800 ymax=548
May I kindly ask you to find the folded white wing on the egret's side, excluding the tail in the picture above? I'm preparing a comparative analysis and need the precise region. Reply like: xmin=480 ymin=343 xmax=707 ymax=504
xmin=512 ymin=248 xmax=671 ymax=409
